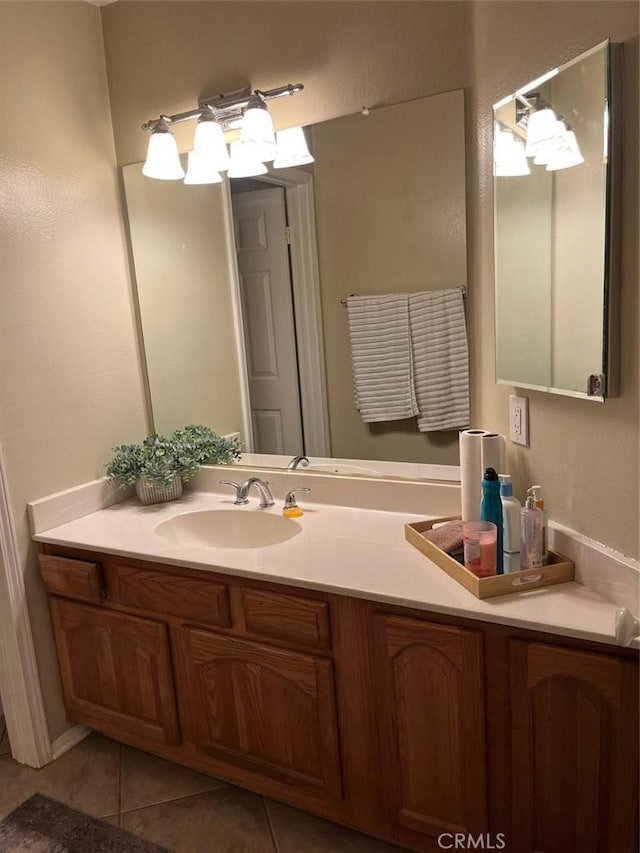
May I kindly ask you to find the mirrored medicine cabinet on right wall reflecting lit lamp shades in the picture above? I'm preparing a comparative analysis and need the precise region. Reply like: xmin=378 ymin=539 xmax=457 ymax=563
xmin=494 ymin=42 xmax=617 ymax=400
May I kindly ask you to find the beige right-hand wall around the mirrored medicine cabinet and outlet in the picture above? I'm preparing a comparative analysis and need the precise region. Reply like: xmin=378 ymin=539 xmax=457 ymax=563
xmin=467 ymin=1 xmax=640 ymax=558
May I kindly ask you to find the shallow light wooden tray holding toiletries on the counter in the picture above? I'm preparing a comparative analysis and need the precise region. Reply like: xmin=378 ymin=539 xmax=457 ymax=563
xmin=404 ymin=516 xmax=574 ymax=598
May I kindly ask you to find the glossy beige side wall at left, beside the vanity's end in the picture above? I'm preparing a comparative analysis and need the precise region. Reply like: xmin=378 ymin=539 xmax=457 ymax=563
xmin=0 ymin=2 xmax=146 ymax=738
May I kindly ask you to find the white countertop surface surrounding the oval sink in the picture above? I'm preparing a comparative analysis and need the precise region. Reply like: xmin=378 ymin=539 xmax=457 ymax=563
xmin=34 ymin=492 xmax=632 ymax=644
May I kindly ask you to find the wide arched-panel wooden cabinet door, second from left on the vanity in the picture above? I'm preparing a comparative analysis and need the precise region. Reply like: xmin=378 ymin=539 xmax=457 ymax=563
xmin=170 ymin=627 xmax=340 ymax=799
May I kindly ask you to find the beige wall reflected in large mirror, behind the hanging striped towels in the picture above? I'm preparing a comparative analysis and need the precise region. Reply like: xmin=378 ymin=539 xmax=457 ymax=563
xmin=309 ymin=90 xmax=467 ymax=465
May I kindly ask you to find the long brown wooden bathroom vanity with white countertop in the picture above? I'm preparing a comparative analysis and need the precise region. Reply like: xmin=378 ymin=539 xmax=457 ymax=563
xmin=36 ymin=482 xmax=638 ymax=853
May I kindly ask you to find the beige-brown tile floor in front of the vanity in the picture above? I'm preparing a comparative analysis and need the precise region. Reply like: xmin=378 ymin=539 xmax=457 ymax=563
xmin=0 ymin=723 xmax=401 ymax=853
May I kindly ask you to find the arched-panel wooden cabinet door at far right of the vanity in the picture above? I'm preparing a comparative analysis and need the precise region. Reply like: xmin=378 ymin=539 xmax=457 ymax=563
xmin=511 ymin=640 xmax=638 ymax=853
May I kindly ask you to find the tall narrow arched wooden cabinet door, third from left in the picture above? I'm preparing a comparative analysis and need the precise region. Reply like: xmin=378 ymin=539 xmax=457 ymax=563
xmin=375 ymin=616 xmax=486 ymax=846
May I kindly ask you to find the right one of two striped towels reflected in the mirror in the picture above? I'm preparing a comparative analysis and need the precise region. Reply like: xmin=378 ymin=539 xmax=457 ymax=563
xmin=409 ymin=288 xmax=469 ymax=432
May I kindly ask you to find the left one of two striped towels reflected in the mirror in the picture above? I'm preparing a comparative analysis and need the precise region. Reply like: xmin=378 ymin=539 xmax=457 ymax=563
xmin=347 ymin=293 xmax=418 ymax=423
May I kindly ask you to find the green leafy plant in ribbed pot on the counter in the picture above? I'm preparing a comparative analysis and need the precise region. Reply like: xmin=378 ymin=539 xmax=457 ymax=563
xmin=107 ymin=425 xmax=240 ymax=504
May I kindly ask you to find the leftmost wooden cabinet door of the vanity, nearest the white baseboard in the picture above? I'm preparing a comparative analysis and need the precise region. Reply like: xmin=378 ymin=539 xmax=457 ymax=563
xmin=51 ymin=597 xmax=179 ymax=744
